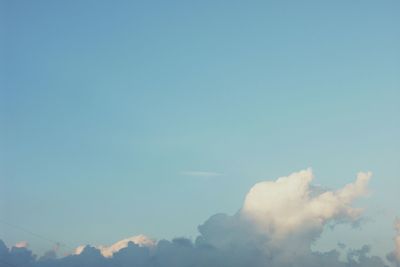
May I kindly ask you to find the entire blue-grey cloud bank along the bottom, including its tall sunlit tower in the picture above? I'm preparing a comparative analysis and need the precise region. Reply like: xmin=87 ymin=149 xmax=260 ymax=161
xmin=0 ymin=169 xmax=400 ymax=267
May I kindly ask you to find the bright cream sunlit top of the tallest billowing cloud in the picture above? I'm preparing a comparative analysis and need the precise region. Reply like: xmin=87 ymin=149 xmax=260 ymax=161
xmin=241 ymin=169 xmax=371 ymax=241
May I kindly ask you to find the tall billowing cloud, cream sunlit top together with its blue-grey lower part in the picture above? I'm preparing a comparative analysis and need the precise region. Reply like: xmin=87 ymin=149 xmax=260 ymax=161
xmin=198 ymin=169 xmax=378 ymax=266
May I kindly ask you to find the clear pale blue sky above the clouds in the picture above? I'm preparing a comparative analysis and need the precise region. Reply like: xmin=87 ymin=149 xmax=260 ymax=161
xmin=0 ymin=0 xmax=400 ymax=266
